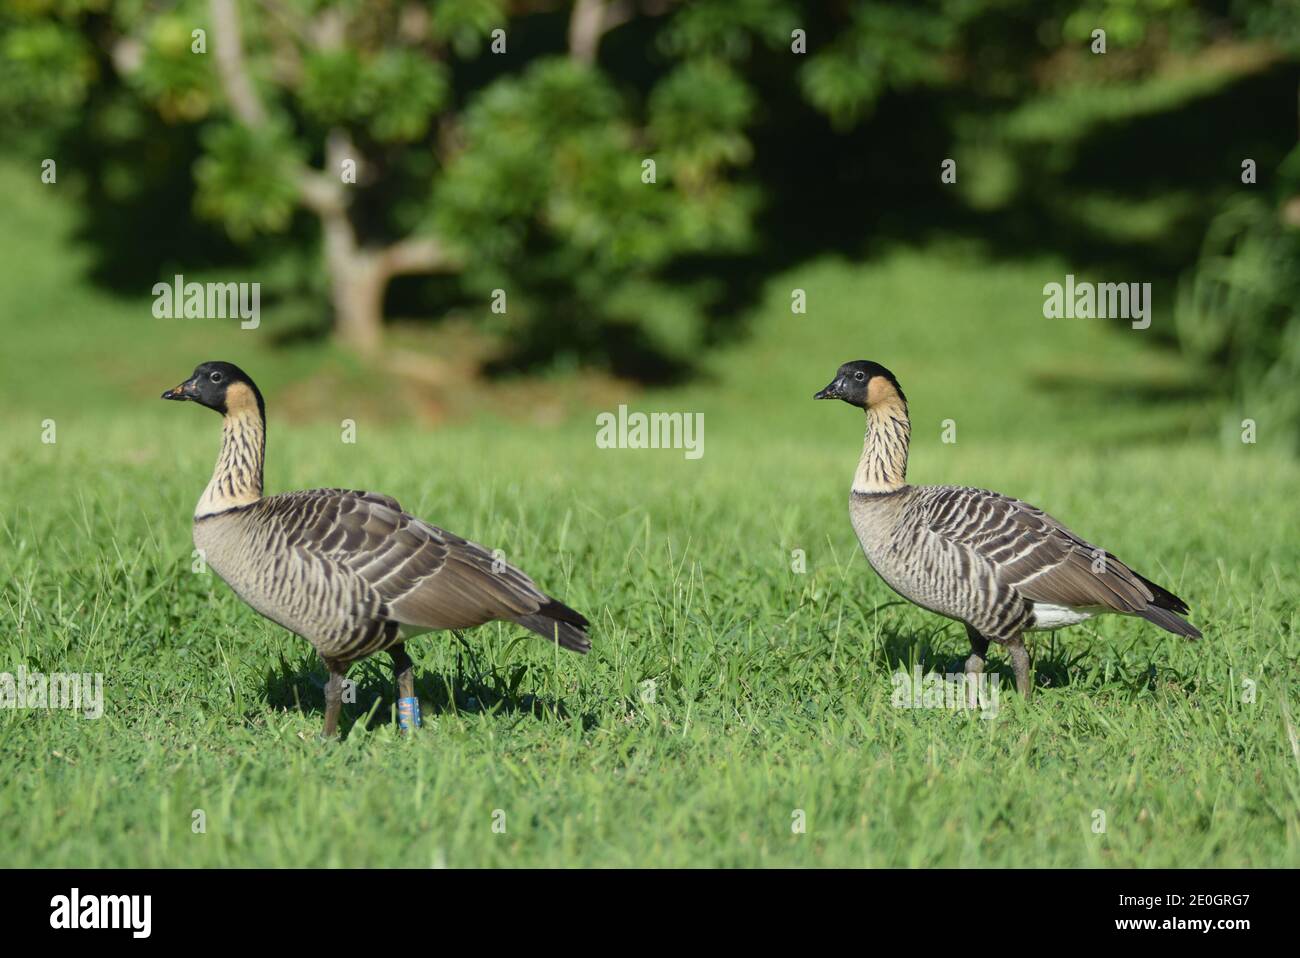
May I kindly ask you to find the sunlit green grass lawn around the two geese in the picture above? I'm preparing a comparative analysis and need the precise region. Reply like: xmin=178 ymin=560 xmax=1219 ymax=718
xmin=0 ymin=158 xmax=1300 ymax=867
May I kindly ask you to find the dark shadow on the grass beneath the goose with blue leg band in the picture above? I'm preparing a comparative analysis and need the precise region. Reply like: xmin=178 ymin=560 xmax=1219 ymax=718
xmin=265 ymin=641 xmax=597 ymax=738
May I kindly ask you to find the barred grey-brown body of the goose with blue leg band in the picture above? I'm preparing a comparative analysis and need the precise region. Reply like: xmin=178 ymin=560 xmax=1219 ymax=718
xmin=194 ymin=489 xmax=590 ymax=667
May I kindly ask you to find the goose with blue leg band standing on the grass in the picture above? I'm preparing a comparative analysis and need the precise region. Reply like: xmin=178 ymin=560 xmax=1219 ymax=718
xmin=163 ymin=363 xmax=592 ymax=737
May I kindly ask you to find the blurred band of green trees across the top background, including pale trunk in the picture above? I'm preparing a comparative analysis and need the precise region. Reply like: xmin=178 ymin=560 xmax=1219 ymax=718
xmin=0 ymin=0 xmax=1294 ymax=379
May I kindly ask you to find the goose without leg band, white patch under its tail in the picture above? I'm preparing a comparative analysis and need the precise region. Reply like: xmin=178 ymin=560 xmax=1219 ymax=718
xmin=813 ymin=360 xmax=1201 ymax=695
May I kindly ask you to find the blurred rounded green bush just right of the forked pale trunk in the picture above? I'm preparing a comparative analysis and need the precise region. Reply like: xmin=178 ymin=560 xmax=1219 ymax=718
xmin=432 ymin=58 xmax=749 ymax=356
